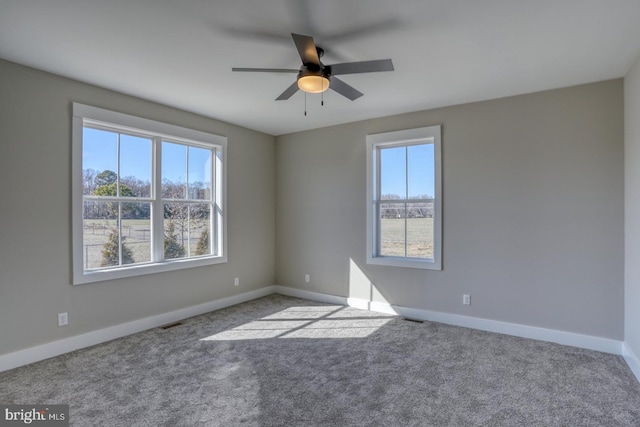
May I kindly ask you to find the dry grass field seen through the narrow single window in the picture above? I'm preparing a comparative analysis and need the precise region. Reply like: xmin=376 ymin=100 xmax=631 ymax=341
xmin=380 ymin=218 xmax=433 ymax=258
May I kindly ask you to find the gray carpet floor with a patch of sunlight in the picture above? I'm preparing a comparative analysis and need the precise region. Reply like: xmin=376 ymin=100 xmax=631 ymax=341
xmin=0 ymin=295 xmax=640 ymax=427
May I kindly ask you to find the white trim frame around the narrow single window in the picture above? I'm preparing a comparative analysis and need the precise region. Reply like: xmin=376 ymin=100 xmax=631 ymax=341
xmin=367 ymin=125 xmax=442 ymax=270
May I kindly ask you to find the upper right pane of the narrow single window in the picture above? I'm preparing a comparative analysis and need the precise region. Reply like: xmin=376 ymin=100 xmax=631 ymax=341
xmin=407 ymin=144 xmax=435 ymax=199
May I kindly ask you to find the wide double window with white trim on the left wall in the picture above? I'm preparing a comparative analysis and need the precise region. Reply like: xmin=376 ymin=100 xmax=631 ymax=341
xmin=72 ymin=104 xmax=226 ymax=284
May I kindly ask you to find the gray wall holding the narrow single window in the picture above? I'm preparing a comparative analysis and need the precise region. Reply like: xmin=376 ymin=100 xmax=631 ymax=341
xmin=276 ymin=79 xmax=624 ymax=340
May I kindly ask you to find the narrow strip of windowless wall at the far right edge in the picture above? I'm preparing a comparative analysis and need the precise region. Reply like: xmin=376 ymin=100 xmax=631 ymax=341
xmin=624 ymin=56 xmax=640 ymax=357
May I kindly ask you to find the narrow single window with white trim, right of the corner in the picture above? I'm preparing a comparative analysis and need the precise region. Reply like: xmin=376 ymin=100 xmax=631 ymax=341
xmin=367 ymin=126 xmax=442 ymax=270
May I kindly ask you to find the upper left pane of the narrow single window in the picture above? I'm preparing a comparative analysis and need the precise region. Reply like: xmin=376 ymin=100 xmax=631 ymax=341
xmin=380 ymin=147 xmax=407 ymax=199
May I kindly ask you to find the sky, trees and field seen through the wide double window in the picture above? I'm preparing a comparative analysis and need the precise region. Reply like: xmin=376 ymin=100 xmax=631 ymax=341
xmin=82 ymin=126 xmax=215 ymax=270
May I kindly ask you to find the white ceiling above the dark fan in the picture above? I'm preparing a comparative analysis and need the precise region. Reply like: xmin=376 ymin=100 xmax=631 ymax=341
xmin=0 ymin=0 xmax=640 ymax=135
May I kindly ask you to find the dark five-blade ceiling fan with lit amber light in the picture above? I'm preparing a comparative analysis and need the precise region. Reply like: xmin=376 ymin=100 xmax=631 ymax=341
xmin=231 ymin=33 xmax=393 ymax=101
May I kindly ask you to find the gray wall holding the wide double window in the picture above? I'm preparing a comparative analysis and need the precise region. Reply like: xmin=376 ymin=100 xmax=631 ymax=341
xmin=0 ymin=60 xmax=275 ymax=354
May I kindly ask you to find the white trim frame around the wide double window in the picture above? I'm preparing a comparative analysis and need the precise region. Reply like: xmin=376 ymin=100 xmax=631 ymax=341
xmin=71 ymin=102 xmax=227 ymax=285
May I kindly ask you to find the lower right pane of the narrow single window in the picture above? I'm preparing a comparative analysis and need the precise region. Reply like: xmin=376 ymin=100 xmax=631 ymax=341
xmin=407 ymin=202 xmax=433 ymax=258
